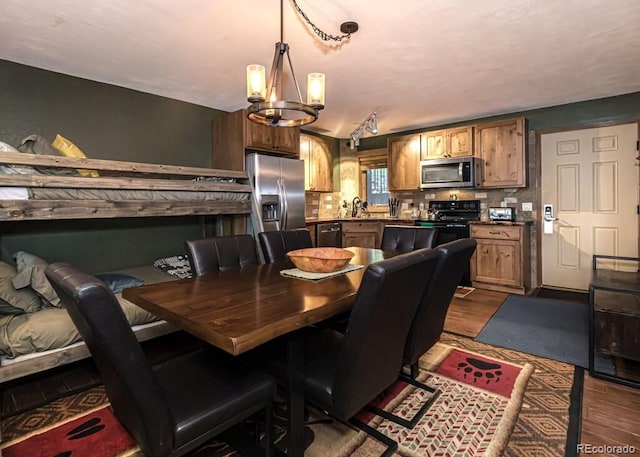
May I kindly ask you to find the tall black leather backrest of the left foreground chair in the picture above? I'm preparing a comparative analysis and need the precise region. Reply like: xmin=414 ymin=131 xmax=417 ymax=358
xmin=46 ymin=263 xmax=173 ymax=455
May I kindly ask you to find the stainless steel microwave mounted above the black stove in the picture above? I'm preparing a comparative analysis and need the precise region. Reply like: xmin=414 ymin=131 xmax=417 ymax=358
xmin=420 ymin=157 xmax=475 ymax=189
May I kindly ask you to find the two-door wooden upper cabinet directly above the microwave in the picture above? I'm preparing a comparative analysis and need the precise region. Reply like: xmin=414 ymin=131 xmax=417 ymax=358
xmin=420 ymin=126 xmax=473 ymax=160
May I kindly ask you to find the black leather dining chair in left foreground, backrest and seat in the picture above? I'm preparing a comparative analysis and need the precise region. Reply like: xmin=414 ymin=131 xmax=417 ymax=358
xmin=46 ymin=263 xmax=275 ymax=457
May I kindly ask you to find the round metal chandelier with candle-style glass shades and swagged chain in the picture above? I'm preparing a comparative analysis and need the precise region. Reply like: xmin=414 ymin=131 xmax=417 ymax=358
xmin=247 ymin=0 xmax=358 ymax=127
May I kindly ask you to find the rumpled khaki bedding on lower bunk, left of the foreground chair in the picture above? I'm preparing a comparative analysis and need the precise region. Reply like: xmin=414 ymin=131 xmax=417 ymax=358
xmin=0 ymin=308 xmax=80 ymax=358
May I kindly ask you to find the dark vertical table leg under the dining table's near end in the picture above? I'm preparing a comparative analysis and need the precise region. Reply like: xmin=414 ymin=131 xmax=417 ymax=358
xmin=287 ymin=331 xmax=304 ymax=457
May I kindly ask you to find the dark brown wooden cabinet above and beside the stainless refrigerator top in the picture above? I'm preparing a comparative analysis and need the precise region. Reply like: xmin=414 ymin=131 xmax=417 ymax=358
xmin=211 ymin=110 xmax=300 ymax=170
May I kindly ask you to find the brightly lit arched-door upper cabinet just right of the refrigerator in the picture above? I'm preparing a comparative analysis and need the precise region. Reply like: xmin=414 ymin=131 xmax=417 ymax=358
xmin=300 ymin=134 xmax=333 ymax=192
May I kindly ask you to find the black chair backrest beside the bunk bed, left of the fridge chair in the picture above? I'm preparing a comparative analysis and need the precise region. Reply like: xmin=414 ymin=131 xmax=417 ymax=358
xmin=185 ymin=235 xmax=258 ymax=276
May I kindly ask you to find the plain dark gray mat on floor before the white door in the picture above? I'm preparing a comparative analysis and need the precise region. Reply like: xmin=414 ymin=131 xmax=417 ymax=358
xmin=475 ymin=295 xmax=589 ymax=368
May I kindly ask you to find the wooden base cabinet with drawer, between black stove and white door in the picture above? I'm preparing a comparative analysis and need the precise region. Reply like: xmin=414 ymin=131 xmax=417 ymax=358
xmin=470 ymin=224 xmax=531 ymax=294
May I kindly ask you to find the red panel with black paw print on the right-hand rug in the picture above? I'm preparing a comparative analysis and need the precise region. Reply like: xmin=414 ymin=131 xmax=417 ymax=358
xmin=435 ymin=349 xmax=522 ymax=397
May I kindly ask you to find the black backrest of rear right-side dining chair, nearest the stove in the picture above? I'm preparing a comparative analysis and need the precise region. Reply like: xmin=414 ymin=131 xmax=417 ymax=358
xmin=404 ymin=238 xmax=476 ymax=372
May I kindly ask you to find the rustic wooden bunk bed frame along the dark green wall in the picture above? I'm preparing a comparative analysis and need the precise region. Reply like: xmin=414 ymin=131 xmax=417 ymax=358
xmin=0 ymin=152 xmax=251 ymax=383
